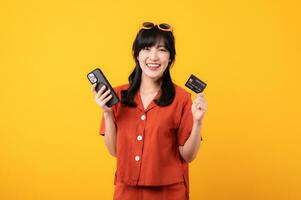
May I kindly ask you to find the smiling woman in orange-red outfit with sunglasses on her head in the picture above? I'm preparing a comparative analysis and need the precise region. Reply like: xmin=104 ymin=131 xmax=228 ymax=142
xmin=92 ymin=22 xmax=207 ymax=200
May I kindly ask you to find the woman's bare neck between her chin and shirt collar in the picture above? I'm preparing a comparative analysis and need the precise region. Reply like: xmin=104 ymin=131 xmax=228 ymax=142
xmin=139 ymin=73 xmax=161 ymax=94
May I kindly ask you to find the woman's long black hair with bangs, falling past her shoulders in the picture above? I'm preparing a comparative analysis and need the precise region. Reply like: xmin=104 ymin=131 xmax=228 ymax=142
xmin=121 ymin=25 xmax=176 ymax=107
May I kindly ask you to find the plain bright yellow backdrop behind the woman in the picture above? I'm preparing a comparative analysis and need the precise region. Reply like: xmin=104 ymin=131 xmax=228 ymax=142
xmin=0 ymin=0 xmax=301 ymax=200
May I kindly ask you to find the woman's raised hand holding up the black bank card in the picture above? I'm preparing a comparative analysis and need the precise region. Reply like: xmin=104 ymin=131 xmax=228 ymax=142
xmin=191 ymin=93 xmax=207 ymax=123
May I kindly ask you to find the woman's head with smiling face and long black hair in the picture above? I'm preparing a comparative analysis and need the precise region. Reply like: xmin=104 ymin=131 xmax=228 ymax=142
xmin=121 ymin=26 xmax=176 ymax=106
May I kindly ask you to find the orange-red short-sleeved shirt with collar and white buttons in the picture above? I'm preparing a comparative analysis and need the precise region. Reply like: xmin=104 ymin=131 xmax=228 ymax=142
xmin=100 ymin=84 xmax=202 ymax=192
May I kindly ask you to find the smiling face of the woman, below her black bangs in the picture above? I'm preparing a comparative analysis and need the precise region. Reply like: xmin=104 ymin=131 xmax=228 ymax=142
xmin=137 ymin=40 xmax=170 ymax=80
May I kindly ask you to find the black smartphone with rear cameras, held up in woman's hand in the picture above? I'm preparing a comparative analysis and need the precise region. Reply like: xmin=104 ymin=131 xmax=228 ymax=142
xmin=87 ymin=68 xmax=120 ymax=107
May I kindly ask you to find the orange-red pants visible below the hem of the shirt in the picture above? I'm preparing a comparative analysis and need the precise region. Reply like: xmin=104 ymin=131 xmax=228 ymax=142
xmin=113 ymin=182 xmax=189 ymax=200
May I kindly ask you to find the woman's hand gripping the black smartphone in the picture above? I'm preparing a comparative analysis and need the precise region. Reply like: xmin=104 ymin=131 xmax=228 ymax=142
xmin=92 ymin=83 xmax=112 ymax=113
